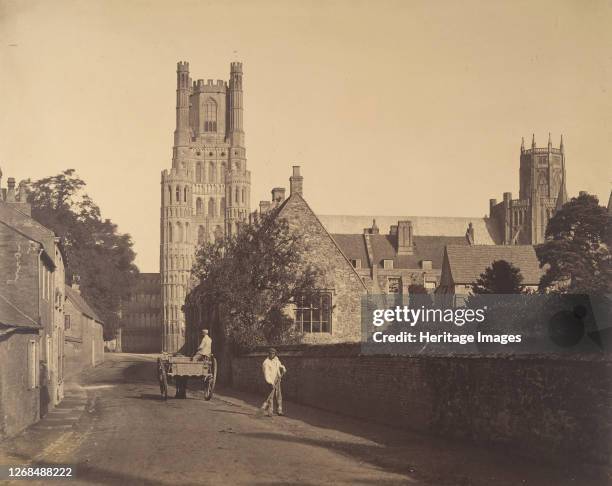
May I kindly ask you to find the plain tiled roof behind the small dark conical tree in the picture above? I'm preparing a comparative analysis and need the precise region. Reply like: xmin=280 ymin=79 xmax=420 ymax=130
xmin=446 ymin=245 xmax=543 ymax=285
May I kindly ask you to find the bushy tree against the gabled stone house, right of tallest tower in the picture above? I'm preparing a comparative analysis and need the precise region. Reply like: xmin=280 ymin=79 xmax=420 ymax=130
xmin=186 ymin=210 xmax=320 ymax=351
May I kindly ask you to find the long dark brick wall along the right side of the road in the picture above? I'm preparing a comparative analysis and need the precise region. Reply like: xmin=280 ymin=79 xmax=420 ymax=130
xmin=232 ymin=345 xmax=612 ymax=466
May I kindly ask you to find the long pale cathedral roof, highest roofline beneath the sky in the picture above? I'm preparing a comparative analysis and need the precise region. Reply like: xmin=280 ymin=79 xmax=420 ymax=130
xmin=318 ymin=215 xmax=501 ymax=245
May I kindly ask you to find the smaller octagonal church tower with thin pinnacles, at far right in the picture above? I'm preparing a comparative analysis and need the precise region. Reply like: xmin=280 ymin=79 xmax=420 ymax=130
xmin=489 ymin=134 xmax=567 ymax=245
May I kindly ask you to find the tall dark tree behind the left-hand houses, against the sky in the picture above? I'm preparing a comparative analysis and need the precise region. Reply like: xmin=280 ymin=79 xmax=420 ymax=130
xmin=25 ymin=169 xmax=138 ymax=338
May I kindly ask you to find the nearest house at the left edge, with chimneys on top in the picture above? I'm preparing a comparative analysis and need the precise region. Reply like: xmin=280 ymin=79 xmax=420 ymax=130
xmin=0 ymin=174 xmax=65 ymax=436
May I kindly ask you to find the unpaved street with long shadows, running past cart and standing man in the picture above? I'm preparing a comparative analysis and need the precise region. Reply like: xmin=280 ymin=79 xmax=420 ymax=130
xmin=0 ymin=354 xmax=604 ymax=486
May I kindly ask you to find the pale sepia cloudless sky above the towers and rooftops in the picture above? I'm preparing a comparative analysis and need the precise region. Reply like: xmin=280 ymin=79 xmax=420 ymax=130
xmin=0 ymin=0 xmax=612 ymax=272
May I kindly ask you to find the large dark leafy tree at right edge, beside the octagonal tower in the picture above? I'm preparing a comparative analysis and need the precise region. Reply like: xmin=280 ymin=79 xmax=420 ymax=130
xmin=536 ymin=193 xmax=612 ymax=294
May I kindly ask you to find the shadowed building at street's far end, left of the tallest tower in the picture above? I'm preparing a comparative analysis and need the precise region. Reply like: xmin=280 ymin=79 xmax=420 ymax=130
xmin=121 ymin=273 xmax=162 ymax=353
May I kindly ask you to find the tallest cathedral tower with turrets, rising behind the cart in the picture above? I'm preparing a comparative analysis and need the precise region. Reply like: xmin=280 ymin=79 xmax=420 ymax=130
xmin=160 ymin=62 xmax=251 ymax=352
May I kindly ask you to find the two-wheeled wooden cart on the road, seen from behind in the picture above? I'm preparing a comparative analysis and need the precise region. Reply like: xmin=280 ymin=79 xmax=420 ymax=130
xmin=157 ymin=353 xmax=217 ymax=400
